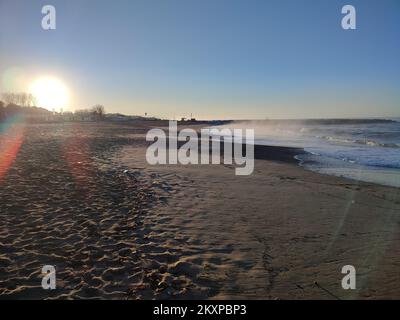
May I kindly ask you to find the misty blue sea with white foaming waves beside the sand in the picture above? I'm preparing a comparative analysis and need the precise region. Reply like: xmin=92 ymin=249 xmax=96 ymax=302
xmin=216 ymin=119 xmax=400 ymax=187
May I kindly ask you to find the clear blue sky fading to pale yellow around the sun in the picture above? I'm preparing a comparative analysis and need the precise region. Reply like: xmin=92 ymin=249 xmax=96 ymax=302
xmin=0 ymin=0 xmax=400 ymax=119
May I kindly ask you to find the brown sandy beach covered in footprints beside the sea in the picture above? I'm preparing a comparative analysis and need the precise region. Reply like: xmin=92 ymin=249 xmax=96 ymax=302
xmin=0 ymin=121 xmax=400 ymax=299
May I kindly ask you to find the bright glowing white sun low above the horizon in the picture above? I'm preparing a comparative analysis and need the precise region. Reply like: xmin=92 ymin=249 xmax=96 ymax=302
xmin=29 ymin=77 xmax=69 ymax=110
